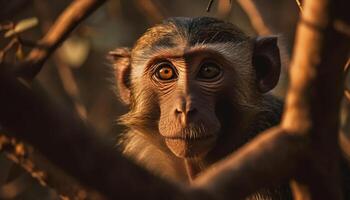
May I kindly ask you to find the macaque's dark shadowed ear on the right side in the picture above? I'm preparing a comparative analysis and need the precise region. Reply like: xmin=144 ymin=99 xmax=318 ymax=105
xmin=253 ymin=36 xmax=281 ymax=93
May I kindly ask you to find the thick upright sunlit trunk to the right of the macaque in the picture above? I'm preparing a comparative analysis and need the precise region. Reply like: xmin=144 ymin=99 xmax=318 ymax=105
xmin=282 ymin=0 xmax=350 ymax=199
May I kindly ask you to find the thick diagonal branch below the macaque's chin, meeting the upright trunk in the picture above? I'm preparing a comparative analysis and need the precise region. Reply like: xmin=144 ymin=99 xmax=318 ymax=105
xmin=194 ymin=127 xmax=307 ymax=199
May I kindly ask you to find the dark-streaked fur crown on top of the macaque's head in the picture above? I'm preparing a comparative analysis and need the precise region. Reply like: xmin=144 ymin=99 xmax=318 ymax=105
xmin=134 ymin=17 xmax=250 ymax=51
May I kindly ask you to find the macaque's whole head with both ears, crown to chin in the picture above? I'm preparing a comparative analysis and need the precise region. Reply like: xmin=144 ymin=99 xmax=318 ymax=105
xmin=110 ymin=17 xmax=280 ymax=158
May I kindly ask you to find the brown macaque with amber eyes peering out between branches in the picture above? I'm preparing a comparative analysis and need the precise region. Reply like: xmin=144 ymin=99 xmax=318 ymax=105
xmin=110 ymin=17 xmax=291 ymax=200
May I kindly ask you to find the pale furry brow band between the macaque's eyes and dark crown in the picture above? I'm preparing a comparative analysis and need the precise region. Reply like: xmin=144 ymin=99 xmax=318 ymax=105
xmin=131 ymin=41 xmax=253 ymax=77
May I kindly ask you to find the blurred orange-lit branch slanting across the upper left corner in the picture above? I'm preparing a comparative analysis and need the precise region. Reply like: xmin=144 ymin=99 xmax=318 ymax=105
xmin=16 ymin=0 xmax=106 ymax=80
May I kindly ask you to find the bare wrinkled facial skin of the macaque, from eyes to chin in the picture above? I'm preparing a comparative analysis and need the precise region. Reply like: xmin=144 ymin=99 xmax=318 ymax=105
xmin=147 ymin=48 xmax=246 ymax=158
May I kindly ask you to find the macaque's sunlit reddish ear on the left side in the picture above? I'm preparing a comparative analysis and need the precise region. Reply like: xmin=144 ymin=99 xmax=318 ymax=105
xmin=108 ymin=47 xmax=131 ymax=105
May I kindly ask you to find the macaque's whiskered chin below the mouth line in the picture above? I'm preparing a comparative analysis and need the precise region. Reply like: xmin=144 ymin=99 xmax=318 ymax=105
xmin=165 ymin=135 xmax=217 ymax=159
